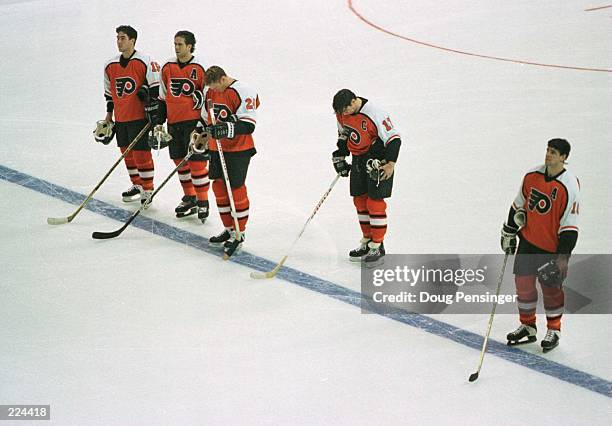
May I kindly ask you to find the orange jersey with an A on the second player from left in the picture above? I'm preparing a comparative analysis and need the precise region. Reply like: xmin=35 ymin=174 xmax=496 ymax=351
xmin=159 ymin=55 xmax=206 ymax=124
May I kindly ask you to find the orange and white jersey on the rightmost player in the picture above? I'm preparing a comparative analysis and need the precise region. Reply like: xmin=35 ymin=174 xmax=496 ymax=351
xmin=513 ymin=165 xmax=580 ymax=253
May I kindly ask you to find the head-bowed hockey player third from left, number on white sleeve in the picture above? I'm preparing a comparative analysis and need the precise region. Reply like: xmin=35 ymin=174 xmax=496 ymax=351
xmin=194 ymin=65 xmax=259 ymax=257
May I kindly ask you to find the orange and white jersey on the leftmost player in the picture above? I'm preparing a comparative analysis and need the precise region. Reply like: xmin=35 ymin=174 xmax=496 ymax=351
xmin=104 ymin=51 xmax=160 ymax=122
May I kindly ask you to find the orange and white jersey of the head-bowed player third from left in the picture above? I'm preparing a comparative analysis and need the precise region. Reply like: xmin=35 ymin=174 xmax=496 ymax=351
xmin=202 ymin=80 xmax=259 ymax=152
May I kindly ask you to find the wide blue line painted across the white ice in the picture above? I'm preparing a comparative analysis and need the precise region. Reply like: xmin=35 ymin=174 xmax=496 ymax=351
xmin=0 ymin=165 xmax=612 ymax=398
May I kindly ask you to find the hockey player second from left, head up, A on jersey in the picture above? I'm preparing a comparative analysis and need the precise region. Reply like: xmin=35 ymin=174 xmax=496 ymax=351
xmin=159 ymin=31 xmax=210 ymax=222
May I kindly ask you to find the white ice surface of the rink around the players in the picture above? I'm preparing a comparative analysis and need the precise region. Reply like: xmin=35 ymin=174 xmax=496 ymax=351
xmin=0 ymin=0 xmax=612 ymax=425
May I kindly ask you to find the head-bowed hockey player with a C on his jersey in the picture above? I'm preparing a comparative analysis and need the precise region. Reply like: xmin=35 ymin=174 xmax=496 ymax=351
xmin=332 ymin=89 xmax=402 ymax=263
